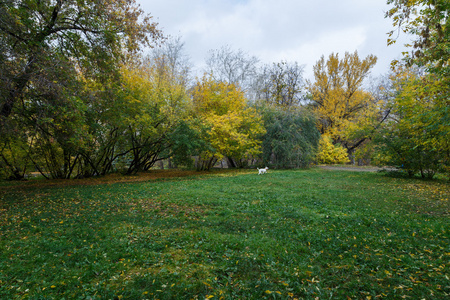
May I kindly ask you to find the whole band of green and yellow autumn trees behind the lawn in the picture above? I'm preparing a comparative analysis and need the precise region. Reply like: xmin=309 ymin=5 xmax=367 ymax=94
xmin=0 ymin=0 xmax=450 ymax=179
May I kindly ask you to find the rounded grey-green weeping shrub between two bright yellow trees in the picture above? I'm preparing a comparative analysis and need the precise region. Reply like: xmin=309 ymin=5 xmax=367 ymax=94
xmin=262 ymin=106 xmax=320 ymax=168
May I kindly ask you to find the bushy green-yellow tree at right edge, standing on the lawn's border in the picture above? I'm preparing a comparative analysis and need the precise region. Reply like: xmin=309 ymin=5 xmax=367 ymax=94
xmin=377 ymin=68 xmax=450 ymax=178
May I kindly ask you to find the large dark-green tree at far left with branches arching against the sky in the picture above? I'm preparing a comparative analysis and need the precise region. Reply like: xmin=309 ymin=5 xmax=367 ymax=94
xmin=0 ymin=0 xmax=161 ymax=178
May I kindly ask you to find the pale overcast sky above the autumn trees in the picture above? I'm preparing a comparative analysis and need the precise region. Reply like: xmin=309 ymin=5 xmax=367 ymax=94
xmin=137 ymin=0 xmax=412 ymax=79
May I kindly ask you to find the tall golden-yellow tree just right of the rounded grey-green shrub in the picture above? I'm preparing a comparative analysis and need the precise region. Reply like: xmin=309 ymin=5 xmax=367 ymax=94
xmin=308 ymin=51 xmax=385 ymax=161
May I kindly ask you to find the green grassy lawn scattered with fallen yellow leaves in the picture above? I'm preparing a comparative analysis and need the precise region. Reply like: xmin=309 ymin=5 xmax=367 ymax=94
xmin=0 ymin=169 xmax=450 ymax=299
